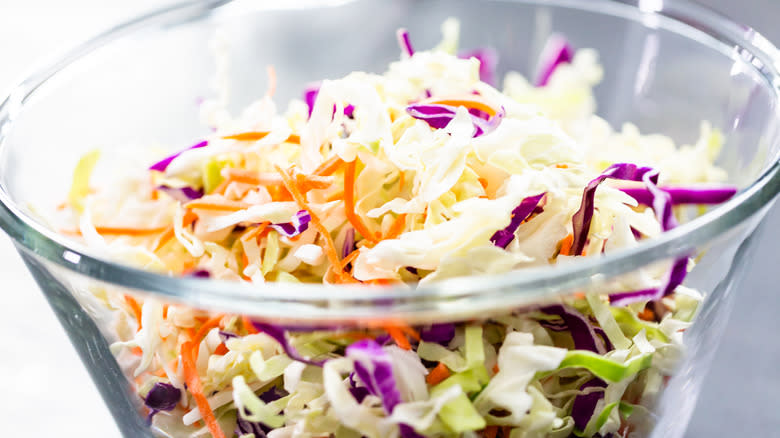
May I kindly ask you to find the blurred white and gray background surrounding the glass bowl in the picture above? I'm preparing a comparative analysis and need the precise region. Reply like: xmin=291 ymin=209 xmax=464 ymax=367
xmin=0 ymin=0 xmax=780 ymax=438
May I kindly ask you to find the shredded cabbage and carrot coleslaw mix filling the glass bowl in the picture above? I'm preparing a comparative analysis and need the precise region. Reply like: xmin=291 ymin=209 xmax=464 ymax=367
xmin=36 ymin=12 xmax=738 ymax=438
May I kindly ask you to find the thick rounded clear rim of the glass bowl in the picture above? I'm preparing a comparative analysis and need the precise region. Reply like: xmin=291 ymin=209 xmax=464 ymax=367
xmin=0 ymin=0 xmax=780 ymax=321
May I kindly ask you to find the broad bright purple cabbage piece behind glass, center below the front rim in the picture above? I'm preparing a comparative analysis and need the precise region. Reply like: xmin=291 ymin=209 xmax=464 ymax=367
xmin=346 ymin=339 xmax=401 ymax=414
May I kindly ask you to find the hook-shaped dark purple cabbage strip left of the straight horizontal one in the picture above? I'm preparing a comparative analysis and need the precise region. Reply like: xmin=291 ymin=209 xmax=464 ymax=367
xmin=571 ymin=163 xmax=658 ymax=255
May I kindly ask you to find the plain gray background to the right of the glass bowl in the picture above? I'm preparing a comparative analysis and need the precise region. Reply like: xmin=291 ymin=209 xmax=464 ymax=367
xmin=687 ymin=0 xmax=780 ymax=437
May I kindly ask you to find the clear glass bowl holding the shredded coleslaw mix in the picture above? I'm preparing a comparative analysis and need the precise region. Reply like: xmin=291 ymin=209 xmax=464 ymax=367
xmin=0 ymin=0 xmax=780 ymax=437
